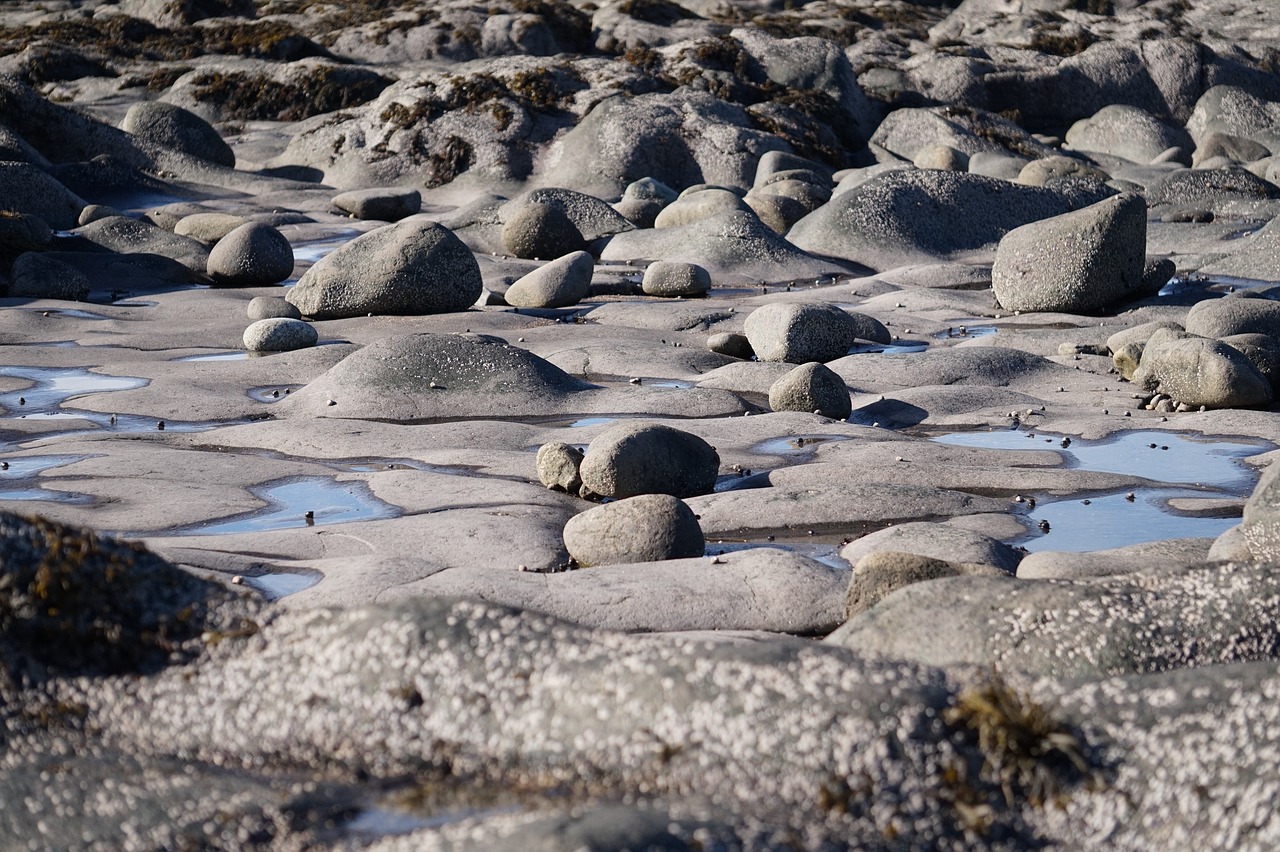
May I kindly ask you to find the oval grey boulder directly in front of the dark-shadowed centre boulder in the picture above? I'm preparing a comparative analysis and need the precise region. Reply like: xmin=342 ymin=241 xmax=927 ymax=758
xmin=564 ymin=494 xmax=705 ymax=568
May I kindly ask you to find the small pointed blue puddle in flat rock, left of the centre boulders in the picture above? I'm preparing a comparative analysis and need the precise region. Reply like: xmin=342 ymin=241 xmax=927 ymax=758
xmin=161 ymin=476 xmax=401 ymax=536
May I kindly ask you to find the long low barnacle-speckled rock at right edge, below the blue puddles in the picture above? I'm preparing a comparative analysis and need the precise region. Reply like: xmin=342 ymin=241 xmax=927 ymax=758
xmin=827 ymin=564 xmax=1280 ymax=678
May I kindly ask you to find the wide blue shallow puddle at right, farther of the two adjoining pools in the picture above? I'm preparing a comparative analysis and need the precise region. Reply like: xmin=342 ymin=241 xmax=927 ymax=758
xmin=933 ymin=429 xmax=1272 ymax=490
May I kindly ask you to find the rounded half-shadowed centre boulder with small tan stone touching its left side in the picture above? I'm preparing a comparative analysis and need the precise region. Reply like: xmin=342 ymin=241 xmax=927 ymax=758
xmin=581 ymin=422 xmax=719 ymax=499
